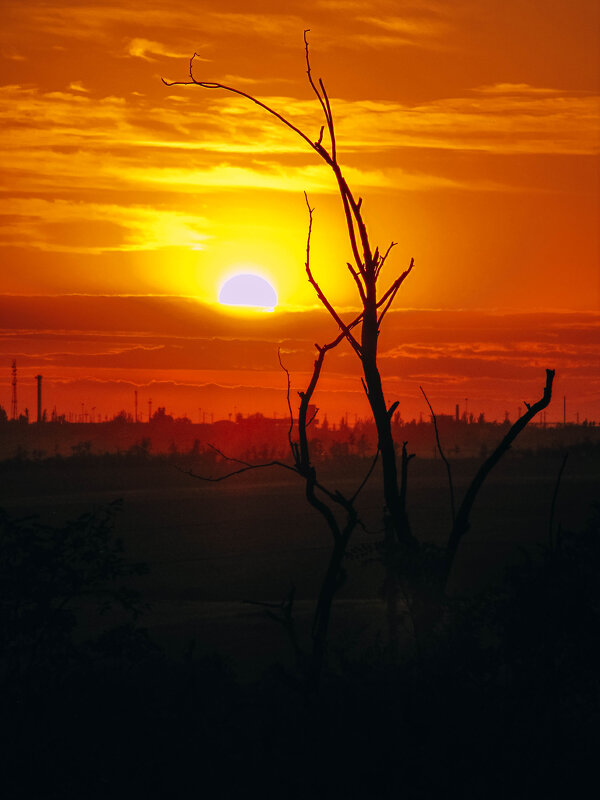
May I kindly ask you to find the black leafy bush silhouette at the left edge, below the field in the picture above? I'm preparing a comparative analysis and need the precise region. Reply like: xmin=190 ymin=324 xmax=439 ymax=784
xmin=0 ymin=501 xmax=146 ymax=683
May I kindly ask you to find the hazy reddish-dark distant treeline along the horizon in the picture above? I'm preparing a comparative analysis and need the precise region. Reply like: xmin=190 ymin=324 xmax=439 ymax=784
xmin=0 ymin=407 xmax=600 ymax=463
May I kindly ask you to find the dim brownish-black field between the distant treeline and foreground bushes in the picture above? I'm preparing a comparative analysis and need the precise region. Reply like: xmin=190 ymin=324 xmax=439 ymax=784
xmin=0 ymin=453 xmax=600 ymax=674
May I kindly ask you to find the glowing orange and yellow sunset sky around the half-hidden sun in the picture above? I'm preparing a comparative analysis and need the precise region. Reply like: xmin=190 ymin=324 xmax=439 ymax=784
xmin=0 ymin=0 xmax=600 ymax=421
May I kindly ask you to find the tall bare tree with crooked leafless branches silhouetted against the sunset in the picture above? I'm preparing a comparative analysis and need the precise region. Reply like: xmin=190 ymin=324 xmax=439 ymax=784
xmin=163 ymin=30 xmax=554 ymax=663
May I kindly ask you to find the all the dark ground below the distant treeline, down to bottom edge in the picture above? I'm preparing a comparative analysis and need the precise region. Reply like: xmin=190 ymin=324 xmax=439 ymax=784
xmin=0 ymin=453 xmax=600 ymax=798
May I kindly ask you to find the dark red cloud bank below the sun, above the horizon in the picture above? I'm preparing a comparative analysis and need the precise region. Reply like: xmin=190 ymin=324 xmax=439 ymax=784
xmin=0 ymin=296 xmax=600 ymax=418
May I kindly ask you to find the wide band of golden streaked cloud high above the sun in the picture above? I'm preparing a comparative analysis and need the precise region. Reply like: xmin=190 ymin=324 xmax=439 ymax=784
xmin=0 ymin=82 xmax=600 ymax=228
